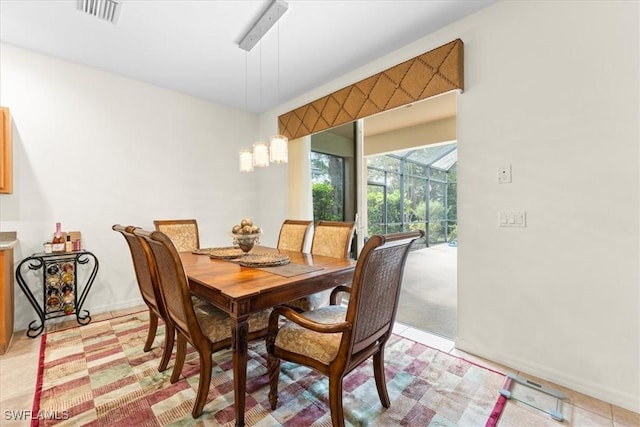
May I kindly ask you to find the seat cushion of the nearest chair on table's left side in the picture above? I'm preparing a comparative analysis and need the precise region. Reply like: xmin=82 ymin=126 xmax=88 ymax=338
xmin=191 ymin=296 xmax=271 ymax=342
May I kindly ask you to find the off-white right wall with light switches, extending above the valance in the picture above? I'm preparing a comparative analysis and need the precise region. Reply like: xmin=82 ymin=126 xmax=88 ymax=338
xmin=261 ymin=1 xmax=640 ymax=411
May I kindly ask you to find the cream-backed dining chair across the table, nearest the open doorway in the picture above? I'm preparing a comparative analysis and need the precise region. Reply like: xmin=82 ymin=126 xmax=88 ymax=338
xmin=288 ymin=221 xmax=356 ymax=311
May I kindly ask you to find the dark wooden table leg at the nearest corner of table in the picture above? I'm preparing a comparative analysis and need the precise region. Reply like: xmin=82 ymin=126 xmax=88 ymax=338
xmin=231 ymin=317 xmax=249 ymax=427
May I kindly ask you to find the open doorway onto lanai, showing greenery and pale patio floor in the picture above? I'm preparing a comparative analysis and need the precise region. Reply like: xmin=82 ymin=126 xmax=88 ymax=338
xmin=367 ymin=142 xmax=457 ymax=340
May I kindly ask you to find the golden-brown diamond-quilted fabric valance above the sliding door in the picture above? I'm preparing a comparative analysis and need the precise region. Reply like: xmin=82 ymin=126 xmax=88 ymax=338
xmin=278 ymin=39 xmax=464 ymax=139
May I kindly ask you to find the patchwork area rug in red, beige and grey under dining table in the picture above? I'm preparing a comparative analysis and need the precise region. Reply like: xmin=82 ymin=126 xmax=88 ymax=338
xmin=32 ymin=312 xmax=505 ymax=427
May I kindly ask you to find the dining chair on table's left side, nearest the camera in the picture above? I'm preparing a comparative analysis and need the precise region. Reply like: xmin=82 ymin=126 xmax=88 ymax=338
xmin=133 ymin=229 xmax=270 ymax=418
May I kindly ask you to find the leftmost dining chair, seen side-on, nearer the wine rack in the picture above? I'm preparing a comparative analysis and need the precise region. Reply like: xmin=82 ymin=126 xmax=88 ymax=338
xmin=111 ymin=224 xmax=175 ymax=371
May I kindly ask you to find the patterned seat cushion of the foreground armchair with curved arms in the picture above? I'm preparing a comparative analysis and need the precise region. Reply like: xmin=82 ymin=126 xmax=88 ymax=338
xmin=275 ymin=305 xmax=347 ymax=365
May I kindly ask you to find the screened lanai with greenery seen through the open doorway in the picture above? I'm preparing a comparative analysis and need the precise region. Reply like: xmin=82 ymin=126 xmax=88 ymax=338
xmin=367 ymin=142 xmax=458 ymax=246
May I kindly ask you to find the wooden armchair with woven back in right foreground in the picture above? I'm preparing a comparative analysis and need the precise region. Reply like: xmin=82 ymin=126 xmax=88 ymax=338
xmin=267 ymin=230 xmax=424 ymax=427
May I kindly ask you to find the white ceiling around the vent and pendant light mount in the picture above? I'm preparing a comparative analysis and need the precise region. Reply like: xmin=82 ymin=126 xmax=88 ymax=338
xmin=0 ymin=0 xmax=495 ymax=113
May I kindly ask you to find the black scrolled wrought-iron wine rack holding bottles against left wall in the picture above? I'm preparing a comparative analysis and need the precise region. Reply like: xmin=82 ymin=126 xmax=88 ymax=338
xmin=16 ymin=250 xmax=98 ymax=338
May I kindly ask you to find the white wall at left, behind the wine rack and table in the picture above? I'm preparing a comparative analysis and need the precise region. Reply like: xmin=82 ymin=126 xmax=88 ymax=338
xmin=0 ymin=44 xmax=286 ymax=330
